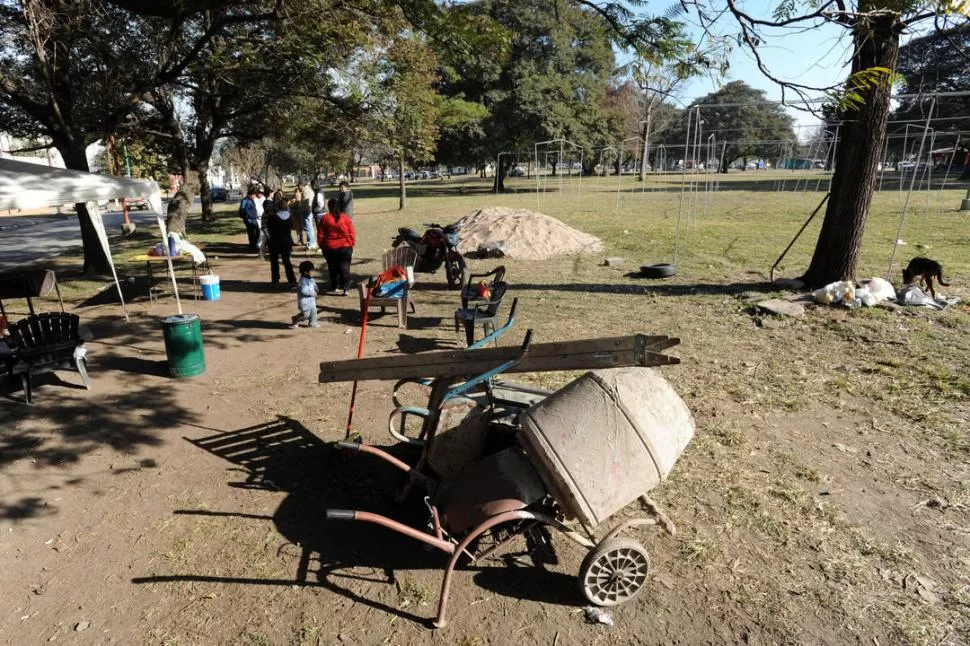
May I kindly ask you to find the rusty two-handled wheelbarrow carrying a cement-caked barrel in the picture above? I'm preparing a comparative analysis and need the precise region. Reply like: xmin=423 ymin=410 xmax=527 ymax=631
xmin=321 ymin=337 xmax=694 ymax=628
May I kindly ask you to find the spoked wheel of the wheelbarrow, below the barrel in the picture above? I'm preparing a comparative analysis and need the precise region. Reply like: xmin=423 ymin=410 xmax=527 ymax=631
xmin=579 ymin=538 xmax=650 ymax=606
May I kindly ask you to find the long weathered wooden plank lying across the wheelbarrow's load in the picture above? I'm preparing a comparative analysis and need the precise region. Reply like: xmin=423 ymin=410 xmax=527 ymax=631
xmin=320 ymin=335 xmax=680 ymax=383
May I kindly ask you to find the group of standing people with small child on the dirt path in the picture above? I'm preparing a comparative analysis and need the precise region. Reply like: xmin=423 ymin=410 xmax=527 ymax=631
xmin=239 ymin=182 xmax=357 ymax=316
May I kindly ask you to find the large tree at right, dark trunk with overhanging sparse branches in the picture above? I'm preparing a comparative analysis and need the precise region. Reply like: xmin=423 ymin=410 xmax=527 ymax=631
xmin=691 ymin=0 xmax=967 ymax=286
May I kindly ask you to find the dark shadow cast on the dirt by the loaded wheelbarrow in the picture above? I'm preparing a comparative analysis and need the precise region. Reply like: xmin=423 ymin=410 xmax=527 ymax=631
xmin=132 ymin=416 xmax=579 ymax=624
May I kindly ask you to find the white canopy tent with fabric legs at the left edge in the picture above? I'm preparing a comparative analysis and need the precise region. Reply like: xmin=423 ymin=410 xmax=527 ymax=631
xmin=0 ymin=158 xmax=173 ymax=319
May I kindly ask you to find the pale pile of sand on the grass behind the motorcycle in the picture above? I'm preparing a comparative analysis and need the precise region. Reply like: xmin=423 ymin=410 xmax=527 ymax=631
xmin=458 ymin=207 xmax=603 ymax=260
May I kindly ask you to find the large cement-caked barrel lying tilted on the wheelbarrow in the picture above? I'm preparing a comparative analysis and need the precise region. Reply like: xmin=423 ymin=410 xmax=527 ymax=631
xmin=519 ymin=368 xmax=694 ymax=529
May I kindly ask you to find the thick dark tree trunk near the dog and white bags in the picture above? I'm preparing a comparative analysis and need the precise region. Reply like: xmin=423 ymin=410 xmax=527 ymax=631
xmin=802 ymin=15 xmax=902 ymax=287
